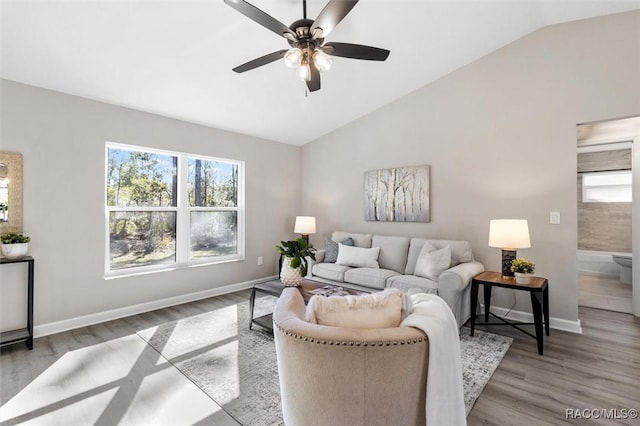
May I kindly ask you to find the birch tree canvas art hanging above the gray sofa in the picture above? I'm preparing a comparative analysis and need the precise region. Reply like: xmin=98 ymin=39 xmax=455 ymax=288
xmin=364 ymin=166 xmax=431 ymax=222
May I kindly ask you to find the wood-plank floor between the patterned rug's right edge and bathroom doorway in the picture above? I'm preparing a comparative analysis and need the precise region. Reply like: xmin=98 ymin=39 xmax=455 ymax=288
xmin=468 ymin=307 xmax=640 ymax=425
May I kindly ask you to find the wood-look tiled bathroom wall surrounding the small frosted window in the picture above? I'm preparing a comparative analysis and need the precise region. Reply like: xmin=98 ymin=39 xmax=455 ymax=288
xmin=578 ymin=149 xmax=632 ymax=253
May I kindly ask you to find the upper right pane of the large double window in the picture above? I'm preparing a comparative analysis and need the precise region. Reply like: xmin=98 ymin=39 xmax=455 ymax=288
xmin=187 ymin=158 xmax=238 ymax=207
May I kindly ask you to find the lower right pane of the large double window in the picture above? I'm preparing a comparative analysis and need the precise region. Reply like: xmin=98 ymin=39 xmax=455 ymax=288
xmin=190 ymin=211 xmax=238 ymax=259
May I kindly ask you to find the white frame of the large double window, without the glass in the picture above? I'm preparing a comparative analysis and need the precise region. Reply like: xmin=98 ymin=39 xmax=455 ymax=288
xmin=103 ymin=142 xmax=245 ymax=279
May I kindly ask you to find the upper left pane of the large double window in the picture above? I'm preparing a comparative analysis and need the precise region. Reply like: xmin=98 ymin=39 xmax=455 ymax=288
xmin=107 ymin=148 xmax=178 ymax=207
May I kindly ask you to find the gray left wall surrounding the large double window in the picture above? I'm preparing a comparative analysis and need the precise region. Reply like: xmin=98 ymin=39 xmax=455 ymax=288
xmin=0 ymin=80 xmax=300 ymax=329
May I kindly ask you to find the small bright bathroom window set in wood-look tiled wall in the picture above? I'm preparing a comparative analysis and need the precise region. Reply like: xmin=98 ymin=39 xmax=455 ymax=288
xmin=582 ymin=170 xmax=632 ymax=203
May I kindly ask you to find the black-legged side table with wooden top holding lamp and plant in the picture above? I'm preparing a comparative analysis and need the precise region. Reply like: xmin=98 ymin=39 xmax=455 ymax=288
xmin=471 ymin=271 xmax=549 ymax=355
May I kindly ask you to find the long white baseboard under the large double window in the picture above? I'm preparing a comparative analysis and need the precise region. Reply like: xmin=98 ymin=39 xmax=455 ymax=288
xmin=33 ymin=275 xmax=278 ymax=337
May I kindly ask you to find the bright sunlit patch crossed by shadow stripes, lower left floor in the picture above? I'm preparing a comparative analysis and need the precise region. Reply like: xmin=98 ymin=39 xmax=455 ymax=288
xmin=0 ymin=335 xmax=231 ymax=425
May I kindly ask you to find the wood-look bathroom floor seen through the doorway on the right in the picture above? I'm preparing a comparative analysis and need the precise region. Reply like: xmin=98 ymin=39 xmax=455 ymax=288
xmin=578 ymin=274 xmax=633 ymax=314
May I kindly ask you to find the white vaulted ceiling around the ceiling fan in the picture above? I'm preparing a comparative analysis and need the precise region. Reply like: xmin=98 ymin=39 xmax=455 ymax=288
xmin=0 ymin=0 xmax=640 ymax=145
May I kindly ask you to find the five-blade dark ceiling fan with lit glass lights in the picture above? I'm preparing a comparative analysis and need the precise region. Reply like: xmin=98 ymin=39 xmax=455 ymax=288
xmin=224 ymin=0 xmax=390 ymax=92
